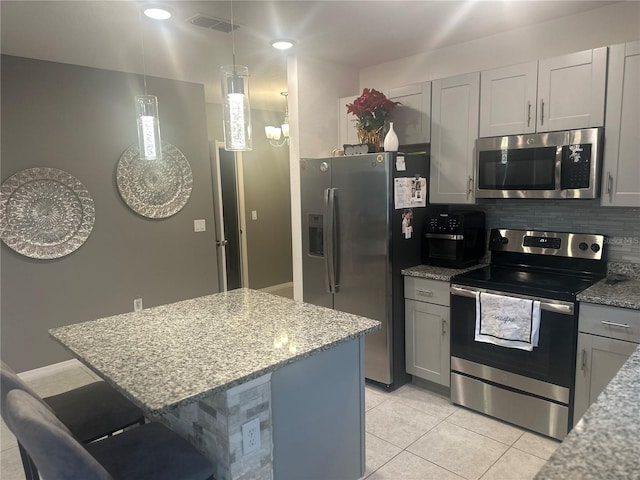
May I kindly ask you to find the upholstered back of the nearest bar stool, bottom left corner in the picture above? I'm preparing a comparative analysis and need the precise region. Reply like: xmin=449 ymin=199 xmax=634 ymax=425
xmin=6 ymin=390 xmax=113 ymax=480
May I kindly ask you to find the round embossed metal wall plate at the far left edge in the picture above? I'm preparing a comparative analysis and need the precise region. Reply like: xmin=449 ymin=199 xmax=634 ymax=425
xmin=0 ymin=167 xmax=96 ymax=259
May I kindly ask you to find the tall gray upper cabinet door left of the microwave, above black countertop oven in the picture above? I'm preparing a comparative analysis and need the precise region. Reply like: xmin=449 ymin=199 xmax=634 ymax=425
xmin=429 ymin=72 xmax=480 ymax=204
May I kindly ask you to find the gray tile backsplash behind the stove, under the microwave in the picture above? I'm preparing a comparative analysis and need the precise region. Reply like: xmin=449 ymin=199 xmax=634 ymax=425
xmin=465 ymin=199 xmax=640 ymax=263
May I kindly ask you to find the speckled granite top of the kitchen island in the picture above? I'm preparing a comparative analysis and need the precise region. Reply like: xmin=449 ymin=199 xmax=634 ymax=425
xmin=49 ymin=289 xmax=381 ymax=415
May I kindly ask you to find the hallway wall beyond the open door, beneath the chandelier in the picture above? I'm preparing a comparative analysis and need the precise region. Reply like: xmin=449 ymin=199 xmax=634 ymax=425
xmin=207 ymin=103 xmax=293 ymax=288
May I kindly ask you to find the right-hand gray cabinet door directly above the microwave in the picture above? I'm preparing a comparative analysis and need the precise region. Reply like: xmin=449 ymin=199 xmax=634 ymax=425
xmin=536 ymin=47 xmax=607 ymax=132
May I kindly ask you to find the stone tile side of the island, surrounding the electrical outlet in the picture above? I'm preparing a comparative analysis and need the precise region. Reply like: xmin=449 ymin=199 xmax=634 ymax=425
xmin=153 ymin=374 xmax=273 ymax=480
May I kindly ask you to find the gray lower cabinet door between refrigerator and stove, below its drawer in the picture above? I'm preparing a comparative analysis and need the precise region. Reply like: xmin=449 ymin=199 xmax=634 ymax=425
xmin=405 ymin=300 xmax=451 ymax=387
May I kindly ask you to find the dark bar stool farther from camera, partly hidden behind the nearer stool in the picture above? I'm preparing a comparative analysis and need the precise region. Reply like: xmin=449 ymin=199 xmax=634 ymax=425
xmin=0 ymin=361 xmax=145 ymax=480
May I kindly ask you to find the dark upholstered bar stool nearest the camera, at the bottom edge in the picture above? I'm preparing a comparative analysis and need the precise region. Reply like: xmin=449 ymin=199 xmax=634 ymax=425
xmin=6 ymin=390 xmax=213 ymax=480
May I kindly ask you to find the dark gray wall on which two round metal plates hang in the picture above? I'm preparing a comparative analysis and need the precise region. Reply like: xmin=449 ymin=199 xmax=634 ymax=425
xmin=0 ymin=56 xmax=218 ymax=371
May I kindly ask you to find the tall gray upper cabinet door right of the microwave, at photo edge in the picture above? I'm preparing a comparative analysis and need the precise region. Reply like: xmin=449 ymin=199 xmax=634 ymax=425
xmin=601 ymin=41 xmax=640 ymax=207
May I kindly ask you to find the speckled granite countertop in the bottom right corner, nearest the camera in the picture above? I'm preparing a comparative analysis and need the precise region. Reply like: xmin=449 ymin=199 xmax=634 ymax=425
xmin=535 ymin=347 xmax=640 ymax=480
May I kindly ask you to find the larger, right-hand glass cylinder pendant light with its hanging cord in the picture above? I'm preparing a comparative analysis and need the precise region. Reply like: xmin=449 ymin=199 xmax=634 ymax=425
xmin=220 ymin=0 xmax=252 ymax=152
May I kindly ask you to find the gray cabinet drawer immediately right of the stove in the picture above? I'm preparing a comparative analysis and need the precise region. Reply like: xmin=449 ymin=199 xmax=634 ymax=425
xmin=578 ymin=303 xmax=640 ymax=343
